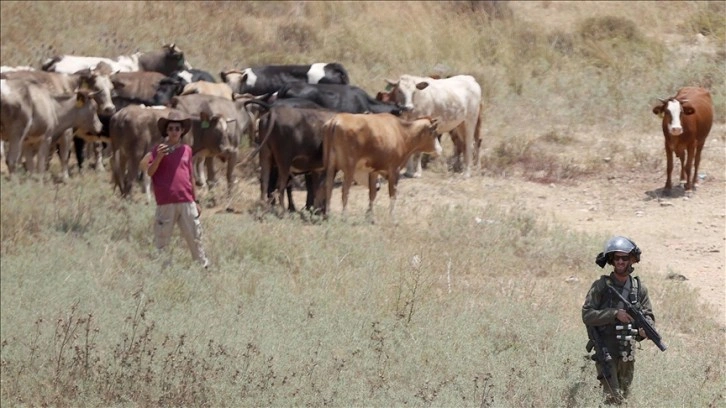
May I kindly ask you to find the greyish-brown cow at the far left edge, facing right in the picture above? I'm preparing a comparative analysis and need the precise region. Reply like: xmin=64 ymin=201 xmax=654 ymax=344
xmin=0 ymin=79 xmax=101 ymax=176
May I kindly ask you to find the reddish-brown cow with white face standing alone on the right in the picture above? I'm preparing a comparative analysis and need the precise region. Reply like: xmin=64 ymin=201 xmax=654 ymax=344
xmin=653 ymin=87 xmax=713 ymax=192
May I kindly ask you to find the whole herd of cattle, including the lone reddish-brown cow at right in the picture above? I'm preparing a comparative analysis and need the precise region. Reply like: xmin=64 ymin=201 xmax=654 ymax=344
xmin=0 ymin=44 xmax=713 ymax=220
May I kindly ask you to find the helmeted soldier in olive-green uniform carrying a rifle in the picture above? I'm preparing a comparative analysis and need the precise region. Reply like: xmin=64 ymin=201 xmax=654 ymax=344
xmin=582 ymin=236 xmax=655 ymax=405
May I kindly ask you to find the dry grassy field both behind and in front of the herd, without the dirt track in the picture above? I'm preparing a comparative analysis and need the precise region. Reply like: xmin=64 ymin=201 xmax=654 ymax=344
xmin=0 ymin=1 xmax=726 ymax=407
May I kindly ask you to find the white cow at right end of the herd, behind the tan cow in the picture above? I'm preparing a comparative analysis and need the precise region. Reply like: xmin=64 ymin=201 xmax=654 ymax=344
xmin=386 ymin=75 xmax=481 ymax=177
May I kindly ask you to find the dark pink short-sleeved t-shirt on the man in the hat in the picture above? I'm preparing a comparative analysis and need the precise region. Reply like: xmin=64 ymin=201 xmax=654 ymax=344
xmin=149 ymin=144 xmax=194 ymax=205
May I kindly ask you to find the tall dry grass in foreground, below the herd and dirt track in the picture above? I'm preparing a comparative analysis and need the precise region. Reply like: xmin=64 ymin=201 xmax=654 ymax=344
xmin=0 ymin=178 xmax=725 ymax=407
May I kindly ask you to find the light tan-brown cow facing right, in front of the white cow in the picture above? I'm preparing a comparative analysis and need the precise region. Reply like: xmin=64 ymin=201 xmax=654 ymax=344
xmin=323 ymin=113 xmax=441 ymax=221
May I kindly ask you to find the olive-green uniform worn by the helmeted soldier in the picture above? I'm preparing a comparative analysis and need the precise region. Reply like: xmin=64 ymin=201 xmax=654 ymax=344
xmin=582 ymin=267 xmax=655 ymax=404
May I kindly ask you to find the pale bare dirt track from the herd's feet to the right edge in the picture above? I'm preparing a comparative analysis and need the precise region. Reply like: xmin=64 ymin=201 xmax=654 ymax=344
xmin=237 ymin=124 xmax=726 ymax=327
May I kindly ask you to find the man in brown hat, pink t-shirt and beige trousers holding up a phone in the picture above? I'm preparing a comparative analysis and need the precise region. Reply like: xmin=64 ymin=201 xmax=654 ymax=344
xmin=141 ymin=110 xmax=209 ymax=268
